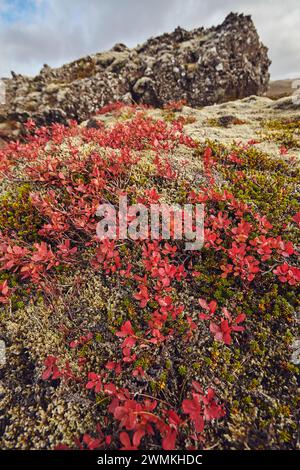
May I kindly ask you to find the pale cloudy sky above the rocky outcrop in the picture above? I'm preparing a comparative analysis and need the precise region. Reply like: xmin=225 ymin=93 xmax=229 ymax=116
xmin=0 ymin=0 xmax=300 ymax=79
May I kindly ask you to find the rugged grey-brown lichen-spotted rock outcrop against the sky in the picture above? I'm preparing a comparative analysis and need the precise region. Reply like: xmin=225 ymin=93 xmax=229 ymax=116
xmin=0 ymin=13 xmax=270 ymax=138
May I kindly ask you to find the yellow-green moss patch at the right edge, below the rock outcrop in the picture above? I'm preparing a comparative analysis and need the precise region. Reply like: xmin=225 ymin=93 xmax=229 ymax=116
xmin=209 ymin=142 xmax=300 ymax=231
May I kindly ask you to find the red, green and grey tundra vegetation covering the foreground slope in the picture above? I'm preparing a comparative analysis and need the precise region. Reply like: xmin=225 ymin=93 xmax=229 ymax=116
xmin=0 ymin=103 xmax=300 ymax=449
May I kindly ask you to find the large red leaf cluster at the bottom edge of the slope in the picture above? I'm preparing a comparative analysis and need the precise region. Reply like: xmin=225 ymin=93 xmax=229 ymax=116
xmin=63 ymin=373 xmax=225 ymax=450
